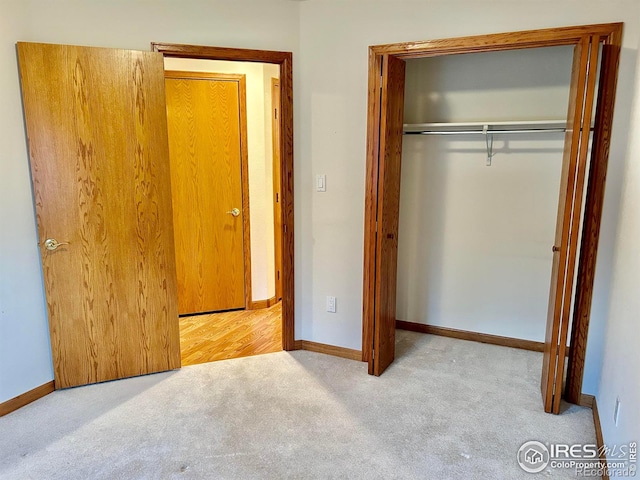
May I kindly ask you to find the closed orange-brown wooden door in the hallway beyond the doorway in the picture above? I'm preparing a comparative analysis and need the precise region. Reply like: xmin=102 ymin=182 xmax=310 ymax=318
xmin=166 ymin=72 xmax=251 ymax=315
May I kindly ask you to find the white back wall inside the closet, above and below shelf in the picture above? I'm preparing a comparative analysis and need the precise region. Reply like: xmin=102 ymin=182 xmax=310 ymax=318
xmin=396 ymin=46 xmax=573 ymax=342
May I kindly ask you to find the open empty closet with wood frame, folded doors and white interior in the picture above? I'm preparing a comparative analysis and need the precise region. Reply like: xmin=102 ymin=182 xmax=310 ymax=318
xmin=363 ymin=24 xmax=622 ymax=413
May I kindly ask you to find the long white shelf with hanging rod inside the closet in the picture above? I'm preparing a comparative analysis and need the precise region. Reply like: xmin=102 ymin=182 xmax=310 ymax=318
xmin=403 ymin=120 xmax=567 ymax=135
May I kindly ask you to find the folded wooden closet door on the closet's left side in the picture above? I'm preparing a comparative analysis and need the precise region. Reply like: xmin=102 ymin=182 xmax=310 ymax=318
xmin=369 ymin=55 xmax=405 ymax=375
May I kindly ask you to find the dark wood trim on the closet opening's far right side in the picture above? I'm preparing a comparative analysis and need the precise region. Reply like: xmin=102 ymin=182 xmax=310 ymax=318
xmin=565 ymin=24 xmax=622 ymax=403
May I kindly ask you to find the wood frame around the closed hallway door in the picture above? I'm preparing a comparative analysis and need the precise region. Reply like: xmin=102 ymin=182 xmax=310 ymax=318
xmin=164 ymin=70 xmax=253 ymax=309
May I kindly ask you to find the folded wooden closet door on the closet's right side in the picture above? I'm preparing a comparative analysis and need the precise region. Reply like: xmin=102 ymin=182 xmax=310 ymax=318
xmin=541 ymin=37 xmax=599 ymax=413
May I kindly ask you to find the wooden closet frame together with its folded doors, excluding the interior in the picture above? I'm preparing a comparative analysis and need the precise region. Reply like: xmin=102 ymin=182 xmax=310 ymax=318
xmin=362 ymin=24 xmax=622 ymax=413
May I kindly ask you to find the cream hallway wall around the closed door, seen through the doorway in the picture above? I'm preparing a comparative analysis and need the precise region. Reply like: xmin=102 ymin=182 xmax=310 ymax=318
xmin=164 ymin=57 xmax=280 ymax=301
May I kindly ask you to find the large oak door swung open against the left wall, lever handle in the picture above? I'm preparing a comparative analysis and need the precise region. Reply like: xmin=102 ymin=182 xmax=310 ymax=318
xmin=18 ymin=43 xmax=180 ymax=388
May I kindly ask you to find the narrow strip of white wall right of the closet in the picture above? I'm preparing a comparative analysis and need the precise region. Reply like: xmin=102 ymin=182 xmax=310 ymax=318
xmin=597 ymin=35 xmax=640 ymax=470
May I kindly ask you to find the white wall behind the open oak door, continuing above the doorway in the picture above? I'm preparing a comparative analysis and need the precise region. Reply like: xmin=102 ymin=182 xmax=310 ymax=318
xmin=0 ymin=0 xmax=299 ymax=402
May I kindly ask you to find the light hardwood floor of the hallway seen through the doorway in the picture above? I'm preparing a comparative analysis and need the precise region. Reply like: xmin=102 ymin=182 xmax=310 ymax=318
xmin=180 ymin=302 xmax=282 ymax=366
